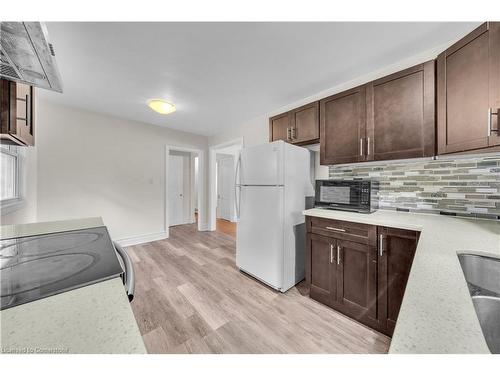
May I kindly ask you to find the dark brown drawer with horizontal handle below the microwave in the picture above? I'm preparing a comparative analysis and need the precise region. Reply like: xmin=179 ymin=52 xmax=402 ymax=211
xmin=307 ymin=217 xmax=377 ymax=246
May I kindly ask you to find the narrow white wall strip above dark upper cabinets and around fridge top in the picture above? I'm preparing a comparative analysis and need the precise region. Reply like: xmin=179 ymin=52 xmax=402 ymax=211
xmin=209 ymin=41 xmax=454 ymax=179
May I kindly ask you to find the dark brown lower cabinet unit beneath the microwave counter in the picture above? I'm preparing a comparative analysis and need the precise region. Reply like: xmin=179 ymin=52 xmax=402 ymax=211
xmin=306 ymin=217 xmax=418 ymax=335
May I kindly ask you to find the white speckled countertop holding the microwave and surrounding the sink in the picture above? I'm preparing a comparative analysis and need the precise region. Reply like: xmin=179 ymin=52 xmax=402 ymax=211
xmin=304 ymin=209 xmax=500 ymax=353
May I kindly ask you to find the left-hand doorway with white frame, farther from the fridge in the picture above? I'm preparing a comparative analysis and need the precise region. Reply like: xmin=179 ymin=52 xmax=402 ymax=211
xmin=165 ymin=146 xmax=203 ymax=238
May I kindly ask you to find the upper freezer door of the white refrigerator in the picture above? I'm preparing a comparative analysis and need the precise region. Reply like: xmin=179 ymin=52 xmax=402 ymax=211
xmin=239 ymin=141 xmax=285 ymax=185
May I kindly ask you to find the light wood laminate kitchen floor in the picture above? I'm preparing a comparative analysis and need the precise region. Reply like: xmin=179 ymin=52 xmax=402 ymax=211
xmin=127 ymin=225 xmax=390 ymax=353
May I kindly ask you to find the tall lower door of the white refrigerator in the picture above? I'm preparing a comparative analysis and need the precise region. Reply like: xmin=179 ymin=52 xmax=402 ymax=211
xmin=236 ymin=186 xmax=284 ymax=289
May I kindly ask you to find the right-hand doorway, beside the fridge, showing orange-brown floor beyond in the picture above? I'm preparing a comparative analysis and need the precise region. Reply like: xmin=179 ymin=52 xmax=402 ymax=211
xmin=210 ymin=139 xmax=243 ymax=238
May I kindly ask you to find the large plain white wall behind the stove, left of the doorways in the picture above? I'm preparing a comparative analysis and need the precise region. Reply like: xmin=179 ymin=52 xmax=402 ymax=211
xmin=36 ymin=101 xmax=208 ymax=239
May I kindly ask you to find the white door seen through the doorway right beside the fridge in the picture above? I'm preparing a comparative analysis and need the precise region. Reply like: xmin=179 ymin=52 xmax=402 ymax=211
xmin=217 ymin=156 xmax=234 ymax=220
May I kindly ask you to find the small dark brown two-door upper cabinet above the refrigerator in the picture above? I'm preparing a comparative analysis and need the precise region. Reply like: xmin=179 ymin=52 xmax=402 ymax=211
xmin=269 ymin=102 xmax=319 ymax=145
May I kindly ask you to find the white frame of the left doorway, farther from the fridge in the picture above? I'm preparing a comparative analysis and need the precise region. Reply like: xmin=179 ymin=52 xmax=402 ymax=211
xmin=164 ymin=145 xmax=207 ymax=238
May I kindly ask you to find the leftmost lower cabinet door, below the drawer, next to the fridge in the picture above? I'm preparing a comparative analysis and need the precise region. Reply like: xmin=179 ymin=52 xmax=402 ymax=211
xmin=307 ymin=234 xmax=337 ymax=305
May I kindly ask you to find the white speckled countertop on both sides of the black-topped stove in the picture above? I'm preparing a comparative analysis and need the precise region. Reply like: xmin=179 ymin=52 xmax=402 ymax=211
xmin=0 ymin=218 xmax=146 ymax=353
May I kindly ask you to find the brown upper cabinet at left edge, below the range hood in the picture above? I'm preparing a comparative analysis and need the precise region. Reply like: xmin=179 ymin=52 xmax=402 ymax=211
xmin=0 ymin=79 xmax=35 ymax=146
